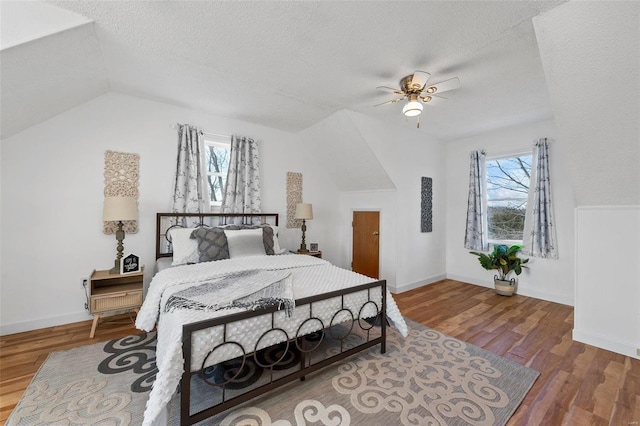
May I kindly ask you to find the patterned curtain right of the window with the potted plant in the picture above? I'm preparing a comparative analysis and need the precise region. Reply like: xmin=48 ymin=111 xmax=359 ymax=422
xmin=523 ymin=138 xmax=558 ymax=259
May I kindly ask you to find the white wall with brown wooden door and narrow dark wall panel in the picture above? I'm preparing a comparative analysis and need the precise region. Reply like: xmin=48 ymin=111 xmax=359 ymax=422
xmin=340 ymin=112 xmax=447 ymax=292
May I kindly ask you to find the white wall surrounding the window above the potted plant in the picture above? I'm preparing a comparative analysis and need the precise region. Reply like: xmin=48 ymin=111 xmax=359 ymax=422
xmin=446 ymin=120 xmax=574 ymax=305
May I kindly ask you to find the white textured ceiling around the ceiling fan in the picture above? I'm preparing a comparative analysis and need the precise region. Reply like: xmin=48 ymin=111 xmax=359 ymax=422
xmin=2 ymin=0 xmax=564 ymax=139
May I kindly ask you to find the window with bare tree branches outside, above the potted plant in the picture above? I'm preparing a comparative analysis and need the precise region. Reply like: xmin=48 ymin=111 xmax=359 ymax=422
xmin=486 ymin=153 xmax=532 ymax=244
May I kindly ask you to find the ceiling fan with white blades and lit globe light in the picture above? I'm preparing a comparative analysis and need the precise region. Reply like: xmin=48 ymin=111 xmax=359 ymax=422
xmin=376 ymin=71 xmax=460 ymax=127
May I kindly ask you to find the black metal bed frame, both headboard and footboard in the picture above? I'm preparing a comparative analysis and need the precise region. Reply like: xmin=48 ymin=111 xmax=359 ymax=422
xmin=156 ymin=213 xmax=387 ymax=425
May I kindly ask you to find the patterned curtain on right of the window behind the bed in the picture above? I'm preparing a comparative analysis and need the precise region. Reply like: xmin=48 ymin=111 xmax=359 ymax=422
xmin=222 ymin=135 xmax=261 ymax=213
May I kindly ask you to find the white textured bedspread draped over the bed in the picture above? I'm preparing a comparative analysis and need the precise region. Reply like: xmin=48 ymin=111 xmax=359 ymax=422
xmin=136 ymin=256 xmax=407 ymax=425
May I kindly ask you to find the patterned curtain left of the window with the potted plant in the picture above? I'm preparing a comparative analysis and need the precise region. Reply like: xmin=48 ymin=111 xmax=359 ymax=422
xmin=464 ymin=151 xmax=489 ymax=251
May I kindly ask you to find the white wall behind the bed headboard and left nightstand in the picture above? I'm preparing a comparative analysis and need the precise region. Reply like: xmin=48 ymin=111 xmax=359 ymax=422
xmin=0 ymin=93 xmax=340 ymax=334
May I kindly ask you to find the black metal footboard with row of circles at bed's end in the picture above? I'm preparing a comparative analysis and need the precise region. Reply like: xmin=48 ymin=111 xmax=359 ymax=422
xmin=180 ymin=280 xmax=387 ymax=425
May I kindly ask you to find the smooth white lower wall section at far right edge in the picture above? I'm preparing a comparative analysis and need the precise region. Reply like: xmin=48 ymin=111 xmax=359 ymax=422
xmin=573 ymin=206 xmax=640 ymax=359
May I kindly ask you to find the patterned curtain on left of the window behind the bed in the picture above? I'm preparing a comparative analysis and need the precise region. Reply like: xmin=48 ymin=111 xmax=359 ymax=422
xmin=171 ymin=124 xmax=209 ymax=226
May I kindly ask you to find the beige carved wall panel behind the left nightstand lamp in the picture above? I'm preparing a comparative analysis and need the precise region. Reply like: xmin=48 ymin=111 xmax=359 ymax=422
xmin=104 ymin=151 xmax=140 ymax=234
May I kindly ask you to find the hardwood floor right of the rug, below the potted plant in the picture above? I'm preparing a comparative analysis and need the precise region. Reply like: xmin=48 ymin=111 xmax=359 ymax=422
xmin=394 ymin=280 xmax=640 ymax=426
